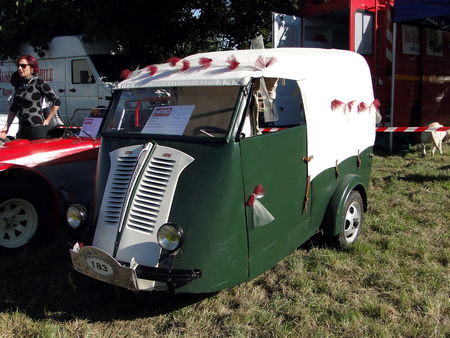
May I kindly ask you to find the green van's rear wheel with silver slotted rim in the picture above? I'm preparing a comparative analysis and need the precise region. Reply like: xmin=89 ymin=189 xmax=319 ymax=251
xmin=336 ymin=190 xmax=364 ymax=248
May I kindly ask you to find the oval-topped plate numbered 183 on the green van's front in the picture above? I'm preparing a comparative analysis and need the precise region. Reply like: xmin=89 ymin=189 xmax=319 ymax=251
xmin=70 ymin=246 xmax=139 ymax=290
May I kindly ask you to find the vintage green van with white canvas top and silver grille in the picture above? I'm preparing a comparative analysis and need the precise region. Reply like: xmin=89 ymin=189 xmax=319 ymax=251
xmin=68 ymin=48 xmax=377 ymax=293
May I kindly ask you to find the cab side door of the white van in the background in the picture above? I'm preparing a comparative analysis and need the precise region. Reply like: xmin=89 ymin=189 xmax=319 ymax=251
xmin=65 ymin=57 xmax=99 ymax=120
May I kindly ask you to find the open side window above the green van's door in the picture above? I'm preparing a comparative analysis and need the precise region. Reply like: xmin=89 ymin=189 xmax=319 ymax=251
xmin=241 ymin=78 xmax=306 ymax=137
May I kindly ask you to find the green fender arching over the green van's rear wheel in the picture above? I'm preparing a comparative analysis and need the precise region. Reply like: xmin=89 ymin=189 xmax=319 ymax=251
xmin=321 ymin=174 xmax=367 ymax=236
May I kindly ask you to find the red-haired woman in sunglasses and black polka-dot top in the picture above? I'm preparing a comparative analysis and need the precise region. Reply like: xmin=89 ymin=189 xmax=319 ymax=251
xmin=0 ymin=55 xmax=61 ymax=140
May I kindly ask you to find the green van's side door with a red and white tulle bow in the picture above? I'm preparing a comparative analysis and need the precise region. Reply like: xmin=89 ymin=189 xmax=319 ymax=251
xmin=240 ymin=79 xmax=314 ymax=277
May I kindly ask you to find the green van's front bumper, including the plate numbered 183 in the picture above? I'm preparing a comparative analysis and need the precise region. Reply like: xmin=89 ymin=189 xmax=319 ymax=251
xmin=70 ymin=243 xmax=202 ymax=291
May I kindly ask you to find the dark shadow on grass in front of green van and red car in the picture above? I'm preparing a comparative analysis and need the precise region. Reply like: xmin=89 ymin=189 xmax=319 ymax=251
xmin=0 ymin=236 xmax=215 ymax=322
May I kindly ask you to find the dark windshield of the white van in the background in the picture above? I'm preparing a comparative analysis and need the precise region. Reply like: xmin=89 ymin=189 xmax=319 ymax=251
xmin=89 ymin=54 xmax=134 ymax=82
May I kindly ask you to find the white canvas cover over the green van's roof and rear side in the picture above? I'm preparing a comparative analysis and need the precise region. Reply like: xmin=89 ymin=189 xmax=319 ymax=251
xmin=118 ymin=48 xmax=377 ymax=179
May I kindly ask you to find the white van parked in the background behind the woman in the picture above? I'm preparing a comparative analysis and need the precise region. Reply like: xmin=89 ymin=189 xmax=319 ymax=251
xmin=0 ymin=36 xmax=130 ymax=136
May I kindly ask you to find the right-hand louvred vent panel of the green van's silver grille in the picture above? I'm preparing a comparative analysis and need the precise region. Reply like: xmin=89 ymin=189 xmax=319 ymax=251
xmin=127 ymin=157 xmax=176 ymax=233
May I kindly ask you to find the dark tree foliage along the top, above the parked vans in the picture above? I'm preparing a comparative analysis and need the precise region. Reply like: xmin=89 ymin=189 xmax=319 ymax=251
xmin=0 ymin=0 xmax=300 ymax=65
